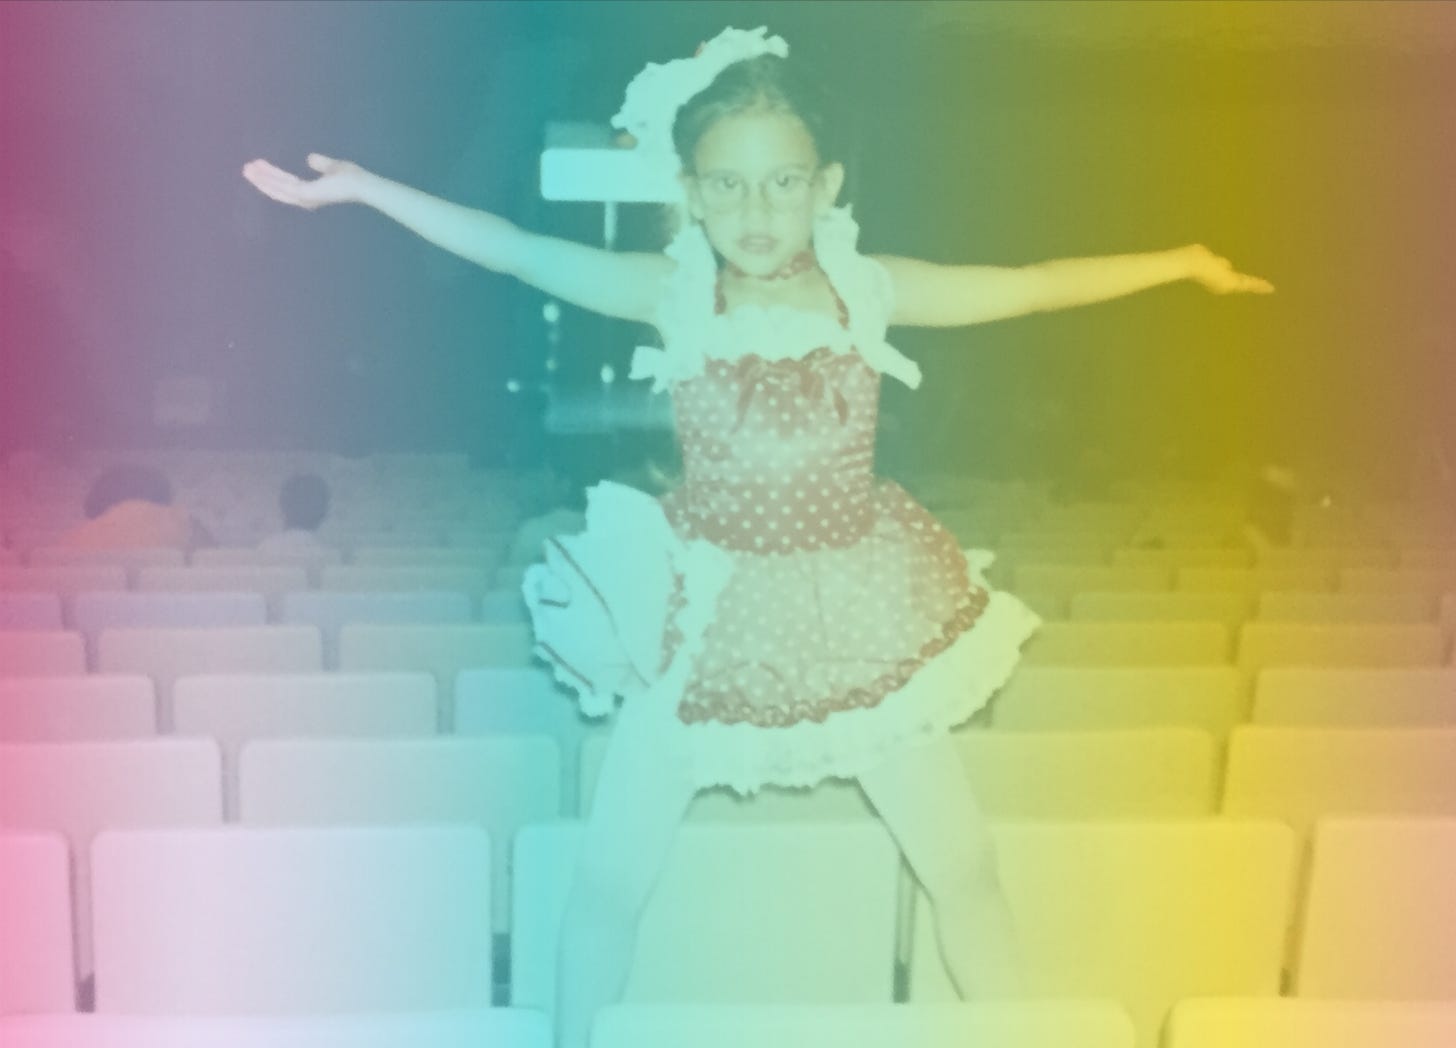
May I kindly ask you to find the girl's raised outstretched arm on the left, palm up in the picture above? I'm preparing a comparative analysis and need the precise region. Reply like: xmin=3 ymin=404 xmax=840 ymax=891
xmin=243 ymin=153 xmax=674 ymax=322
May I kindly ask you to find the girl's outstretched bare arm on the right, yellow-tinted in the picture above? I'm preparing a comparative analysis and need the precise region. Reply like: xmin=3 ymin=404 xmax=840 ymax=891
xmin=877 ymin=245 xmax=1274 ymax=328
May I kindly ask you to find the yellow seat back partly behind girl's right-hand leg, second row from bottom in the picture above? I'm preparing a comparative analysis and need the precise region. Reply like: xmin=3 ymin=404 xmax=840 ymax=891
xmin=910 ymin=819 xmax=1294 ymax=1048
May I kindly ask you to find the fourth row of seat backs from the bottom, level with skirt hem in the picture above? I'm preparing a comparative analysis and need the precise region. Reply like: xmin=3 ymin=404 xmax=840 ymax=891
xmin=0 ymin=665 xmax=1456 ymax=748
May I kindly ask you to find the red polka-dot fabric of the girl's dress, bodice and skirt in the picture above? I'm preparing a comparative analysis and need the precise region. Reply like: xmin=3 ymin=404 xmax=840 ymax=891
xmin=649 ymin=270 xmax=987 ymax=728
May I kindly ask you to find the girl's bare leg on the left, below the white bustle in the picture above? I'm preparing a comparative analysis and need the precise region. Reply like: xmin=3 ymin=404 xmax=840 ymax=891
xmin=556 ymin=700 xmax=695 ymax=1048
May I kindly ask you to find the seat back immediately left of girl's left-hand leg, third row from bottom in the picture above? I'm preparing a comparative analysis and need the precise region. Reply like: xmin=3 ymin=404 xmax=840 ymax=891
xmin=239 ymin=735 xmax=562 ymax=932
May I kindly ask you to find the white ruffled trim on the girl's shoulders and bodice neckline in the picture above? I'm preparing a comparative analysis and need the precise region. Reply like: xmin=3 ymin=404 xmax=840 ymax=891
xmin=630 ymin=207 xmax=920 ymax=392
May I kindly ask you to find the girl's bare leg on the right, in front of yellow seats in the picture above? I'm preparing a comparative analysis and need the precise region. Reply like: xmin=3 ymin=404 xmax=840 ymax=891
xmin=859 ymin=738 xmax=1025 ymax=1000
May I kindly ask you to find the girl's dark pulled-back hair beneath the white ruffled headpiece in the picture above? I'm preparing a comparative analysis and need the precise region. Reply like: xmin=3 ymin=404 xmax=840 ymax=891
xmin=673 ymin=54 xmax=846 ymax=173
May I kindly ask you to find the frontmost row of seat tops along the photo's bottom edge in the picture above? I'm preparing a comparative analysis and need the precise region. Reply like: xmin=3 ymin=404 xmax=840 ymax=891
xmin=8 ymin=999 xmax=1456 ymax=1048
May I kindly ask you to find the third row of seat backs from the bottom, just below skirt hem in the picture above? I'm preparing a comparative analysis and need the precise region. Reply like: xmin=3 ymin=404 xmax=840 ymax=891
xmin=8 ymin=728 xmax=1456 ymax=983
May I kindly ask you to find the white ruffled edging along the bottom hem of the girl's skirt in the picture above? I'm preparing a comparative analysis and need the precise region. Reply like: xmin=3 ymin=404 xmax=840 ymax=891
xmin=678 ymin=591 xmax=1041 ymax=795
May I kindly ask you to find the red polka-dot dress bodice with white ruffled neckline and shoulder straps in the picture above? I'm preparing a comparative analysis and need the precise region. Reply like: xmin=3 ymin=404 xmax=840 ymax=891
xmin=633 ymin=208 xmax=919 ymax=553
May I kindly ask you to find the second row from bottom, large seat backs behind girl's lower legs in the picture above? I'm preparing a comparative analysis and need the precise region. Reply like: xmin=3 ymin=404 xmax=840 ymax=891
xmin=0 ymin=819 xmax=1456 ymax=1048
